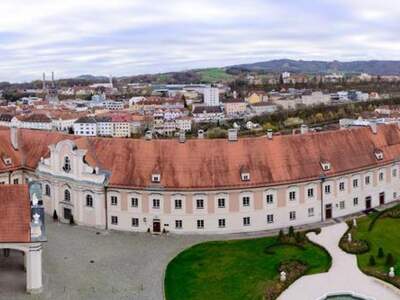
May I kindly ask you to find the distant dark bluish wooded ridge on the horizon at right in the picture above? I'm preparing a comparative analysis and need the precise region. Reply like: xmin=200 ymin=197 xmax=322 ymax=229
xmin=226 ymin=59 xmax=400 ymax=75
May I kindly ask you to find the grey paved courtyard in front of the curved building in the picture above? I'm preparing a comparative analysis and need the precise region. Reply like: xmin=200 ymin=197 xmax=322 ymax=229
xmin=0 ymin=222 xmax=212 ymax=300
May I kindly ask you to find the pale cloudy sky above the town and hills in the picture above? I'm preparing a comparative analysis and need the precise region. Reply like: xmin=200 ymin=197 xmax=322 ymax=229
xmin=0 ymin=0 xmax=400 ymax=81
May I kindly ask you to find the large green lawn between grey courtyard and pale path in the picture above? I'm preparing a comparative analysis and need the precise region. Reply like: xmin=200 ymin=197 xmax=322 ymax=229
xmin=165 ymin=238 xmax=331 ymax=300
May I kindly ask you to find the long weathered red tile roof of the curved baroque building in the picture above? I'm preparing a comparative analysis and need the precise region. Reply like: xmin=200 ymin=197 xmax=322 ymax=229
xmin=0 ymin=124 xmax=400 ymax=190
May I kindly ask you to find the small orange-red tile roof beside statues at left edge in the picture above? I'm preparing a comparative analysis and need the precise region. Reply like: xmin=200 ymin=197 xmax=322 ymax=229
xmin=0 ymin=185 xmax=31 ymax=243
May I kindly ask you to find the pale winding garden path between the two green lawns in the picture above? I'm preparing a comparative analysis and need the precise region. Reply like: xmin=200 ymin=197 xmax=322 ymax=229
xmin=278 ymin=223 xmax=400 ymax=300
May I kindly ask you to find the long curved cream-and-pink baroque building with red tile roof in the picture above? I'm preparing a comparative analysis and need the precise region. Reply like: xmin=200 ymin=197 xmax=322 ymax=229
xmin=0 ymin=124 xmax=400 ymax=234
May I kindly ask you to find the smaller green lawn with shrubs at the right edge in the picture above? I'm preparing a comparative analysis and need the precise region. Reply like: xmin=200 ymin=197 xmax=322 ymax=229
xmin=355 ymin=210 xmax=400 ymax=273
